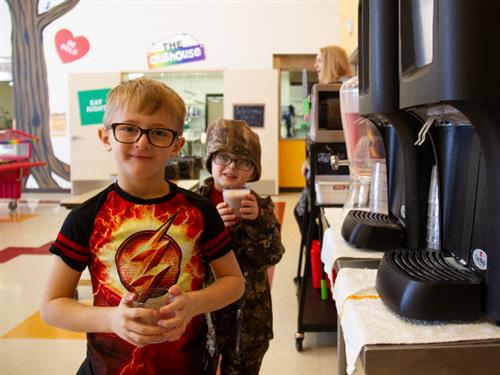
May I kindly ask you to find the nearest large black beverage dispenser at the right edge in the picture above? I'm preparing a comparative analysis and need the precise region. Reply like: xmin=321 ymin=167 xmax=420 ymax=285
xmin=376 ymin=0 xmax=500 ymax=323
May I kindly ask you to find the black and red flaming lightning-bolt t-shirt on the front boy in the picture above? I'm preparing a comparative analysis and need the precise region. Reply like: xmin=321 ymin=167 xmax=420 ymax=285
xmin=50 ymin=184 xmax=231 ymax=374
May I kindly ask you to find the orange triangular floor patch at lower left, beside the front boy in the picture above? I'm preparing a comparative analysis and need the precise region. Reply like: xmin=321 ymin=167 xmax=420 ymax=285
xmin=2 ymin=311 xmax=86 ymax=340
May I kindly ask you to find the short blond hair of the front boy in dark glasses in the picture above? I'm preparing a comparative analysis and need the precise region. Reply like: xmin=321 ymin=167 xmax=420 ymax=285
xmin=103 ymin=78 xmax=186 ymax=134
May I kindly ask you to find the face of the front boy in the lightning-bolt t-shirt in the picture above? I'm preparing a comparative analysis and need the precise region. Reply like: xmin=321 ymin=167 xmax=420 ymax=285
xmin=99 ymin=109 xmax=184 ymax=184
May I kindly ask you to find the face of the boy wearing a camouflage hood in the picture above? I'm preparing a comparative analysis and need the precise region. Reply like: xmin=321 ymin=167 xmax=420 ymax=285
xmin=212 ymin=151 xmax=254 ymax=190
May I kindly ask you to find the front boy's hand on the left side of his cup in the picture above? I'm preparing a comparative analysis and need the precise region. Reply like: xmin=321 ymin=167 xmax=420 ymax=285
xmin=110 ymin=293 xmax=169 ymax=347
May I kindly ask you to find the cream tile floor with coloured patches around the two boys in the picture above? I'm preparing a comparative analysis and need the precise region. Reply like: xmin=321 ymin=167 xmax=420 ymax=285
xmin=0 ymin=193 xmax=337 ymax=375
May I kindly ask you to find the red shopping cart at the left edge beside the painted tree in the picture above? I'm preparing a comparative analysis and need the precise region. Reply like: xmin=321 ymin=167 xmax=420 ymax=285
xmin=0 ymin=129 xmax=47 ymax=211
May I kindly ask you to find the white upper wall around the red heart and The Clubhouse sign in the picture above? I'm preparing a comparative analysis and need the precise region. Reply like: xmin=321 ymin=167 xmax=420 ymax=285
xmin=0 ymin=0 xmax=344 ymax=113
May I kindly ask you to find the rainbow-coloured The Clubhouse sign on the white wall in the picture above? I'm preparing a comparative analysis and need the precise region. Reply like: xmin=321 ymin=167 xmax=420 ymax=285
xmin=148 ymin=34 xmax=205 ymax=68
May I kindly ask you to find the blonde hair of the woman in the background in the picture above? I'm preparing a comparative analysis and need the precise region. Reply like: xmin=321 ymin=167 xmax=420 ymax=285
xmin=318 ymin=46 xmax=353 ymax=83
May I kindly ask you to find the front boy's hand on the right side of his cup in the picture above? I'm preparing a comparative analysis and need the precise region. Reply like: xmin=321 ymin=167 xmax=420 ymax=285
xmin=158 ymin=285 xmax=193 ymax=341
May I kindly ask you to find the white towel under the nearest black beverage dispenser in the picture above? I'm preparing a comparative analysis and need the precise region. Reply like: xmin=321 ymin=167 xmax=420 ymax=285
xmin=333 ymin=268 xmax=500 ymax=375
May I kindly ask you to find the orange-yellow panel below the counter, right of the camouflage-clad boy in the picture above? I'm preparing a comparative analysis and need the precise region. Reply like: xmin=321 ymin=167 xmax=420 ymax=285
xmin=279 ymin=139 xmax=306 ymax=188
